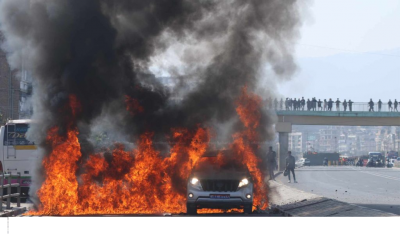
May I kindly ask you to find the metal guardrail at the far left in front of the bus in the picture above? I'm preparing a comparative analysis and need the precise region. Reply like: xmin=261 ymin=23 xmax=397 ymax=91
xmin=0 ymin=173 xmax=21 ymax=211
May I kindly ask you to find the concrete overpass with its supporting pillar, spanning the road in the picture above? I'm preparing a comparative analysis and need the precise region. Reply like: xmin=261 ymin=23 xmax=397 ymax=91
xmin=275 ymin=103 xmax=400 ymax=170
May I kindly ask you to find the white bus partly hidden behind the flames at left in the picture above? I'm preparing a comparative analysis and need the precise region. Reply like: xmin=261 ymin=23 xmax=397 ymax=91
xmin=0 ymin=119 xmax=38 ymax=200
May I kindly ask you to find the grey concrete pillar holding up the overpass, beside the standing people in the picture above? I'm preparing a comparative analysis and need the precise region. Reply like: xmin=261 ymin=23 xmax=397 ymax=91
xmin=275 ymin=122 xmax=292 ymax=171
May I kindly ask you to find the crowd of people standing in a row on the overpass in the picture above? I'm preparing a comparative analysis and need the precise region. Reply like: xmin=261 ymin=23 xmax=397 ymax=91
xmin=267 ymin=97 xmax=399 ymax=112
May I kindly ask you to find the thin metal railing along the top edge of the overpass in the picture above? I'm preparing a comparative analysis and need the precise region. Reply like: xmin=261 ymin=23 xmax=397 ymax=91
xmin=270 ymin=102 xmax=400 ymax=112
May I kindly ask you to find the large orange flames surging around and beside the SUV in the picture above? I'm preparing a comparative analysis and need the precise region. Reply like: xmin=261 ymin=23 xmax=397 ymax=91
xmin=29 ymin=88 xmax=268 ymax=215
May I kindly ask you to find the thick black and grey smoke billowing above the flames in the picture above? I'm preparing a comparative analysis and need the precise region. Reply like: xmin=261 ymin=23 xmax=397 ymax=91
xmin=0 ymin=0 xmax=301 ymax=204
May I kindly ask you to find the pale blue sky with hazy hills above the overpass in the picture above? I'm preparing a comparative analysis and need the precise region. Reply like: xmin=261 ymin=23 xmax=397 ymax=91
xmin=278 ymin=0 xmax=400 ymax=102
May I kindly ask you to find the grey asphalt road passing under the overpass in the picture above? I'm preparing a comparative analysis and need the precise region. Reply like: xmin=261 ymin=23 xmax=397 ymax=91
xmin=276 ymin=166 xmax=400 ymax=215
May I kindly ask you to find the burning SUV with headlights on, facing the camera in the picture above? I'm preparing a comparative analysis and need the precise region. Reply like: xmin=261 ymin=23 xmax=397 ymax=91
xmin=186 ymin=153 xmax=253 ymax=214
